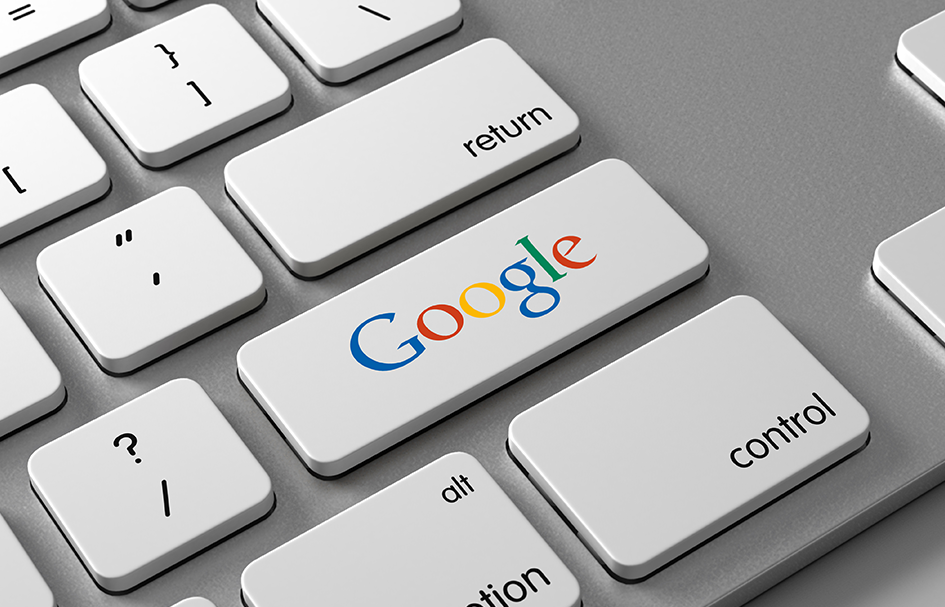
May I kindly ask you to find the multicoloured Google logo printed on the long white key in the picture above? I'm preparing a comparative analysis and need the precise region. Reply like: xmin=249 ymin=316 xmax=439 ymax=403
xmin=351 ymin=236 xmax=597 ymax=371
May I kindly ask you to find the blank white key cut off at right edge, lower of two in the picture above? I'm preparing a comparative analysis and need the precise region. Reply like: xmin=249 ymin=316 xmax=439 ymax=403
xmin=873 ymin=209 xmax=945 ymax=338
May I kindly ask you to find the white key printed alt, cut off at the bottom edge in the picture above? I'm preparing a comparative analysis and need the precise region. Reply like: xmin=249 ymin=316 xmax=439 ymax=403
xmin=242 ymin=453 xmax=581 ymax=607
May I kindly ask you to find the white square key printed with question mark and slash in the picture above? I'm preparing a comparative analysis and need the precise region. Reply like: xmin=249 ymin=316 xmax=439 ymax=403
xmin=28 ymin=379 xmax=275 ymax=593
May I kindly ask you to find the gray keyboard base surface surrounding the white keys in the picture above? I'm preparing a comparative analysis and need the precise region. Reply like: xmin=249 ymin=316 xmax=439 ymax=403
xmin=0 ymin=0 xmax=945 ymax=607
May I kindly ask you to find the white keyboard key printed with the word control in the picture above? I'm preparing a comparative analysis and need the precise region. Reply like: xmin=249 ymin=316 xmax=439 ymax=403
xmin=509 ymin=297 xmax=870 ymax=581
